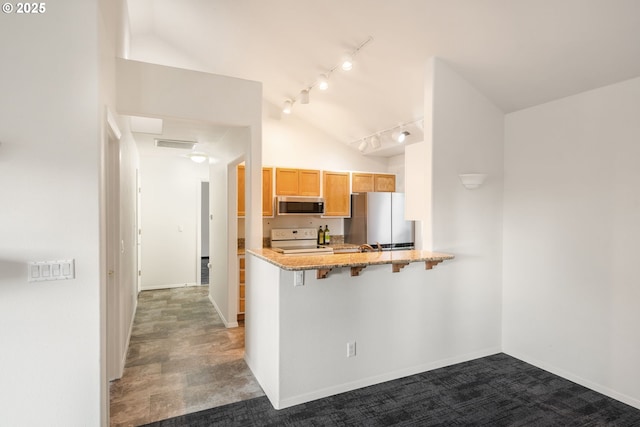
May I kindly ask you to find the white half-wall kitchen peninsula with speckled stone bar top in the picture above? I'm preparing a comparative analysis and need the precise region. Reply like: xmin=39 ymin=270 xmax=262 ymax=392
xmin=245 ymin=248 xmax=458 ymax=409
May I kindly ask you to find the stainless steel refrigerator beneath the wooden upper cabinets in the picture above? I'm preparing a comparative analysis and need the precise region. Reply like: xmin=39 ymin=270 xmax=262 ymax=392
xmin=344 ymin=192 xmax=414 ymax=250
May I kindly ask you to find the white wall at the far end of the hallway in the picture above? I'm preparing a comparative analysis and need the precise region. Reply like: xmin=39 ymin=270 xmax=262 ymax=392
xmin=140 ymin=156 xmax=209 ymax=290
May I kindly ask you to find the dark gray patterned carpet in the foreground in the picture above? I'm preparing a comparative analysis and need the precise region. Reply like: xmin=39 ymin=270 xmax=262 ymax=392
xmin=148 ymin=354 xmax=640 ymax=427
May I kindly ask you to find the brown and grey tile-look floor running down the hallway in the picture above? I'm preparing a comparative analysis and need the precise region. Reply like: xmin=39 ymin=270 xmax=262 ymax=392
xmin=110 ymin=286 xmax=264 ymax=426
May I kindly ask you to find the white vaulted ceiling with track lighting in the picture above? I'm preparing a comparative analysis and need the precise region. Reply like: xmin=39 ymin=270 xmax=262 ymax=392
xmin=128 ymin=0 xmax=640 ymax=155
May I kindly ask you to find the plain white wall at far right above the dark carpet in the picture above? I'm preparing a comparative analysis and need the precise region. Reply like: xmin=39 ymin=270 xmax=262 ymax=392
xmin=503 ymin=78 xmax=640 ymax=408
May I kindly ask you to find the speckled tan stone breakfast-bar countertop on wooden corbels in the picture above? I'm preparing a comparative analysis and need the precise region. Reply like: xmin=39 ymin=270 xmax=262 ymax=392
xmin=247 ymin=248 xmax=454 ymax=276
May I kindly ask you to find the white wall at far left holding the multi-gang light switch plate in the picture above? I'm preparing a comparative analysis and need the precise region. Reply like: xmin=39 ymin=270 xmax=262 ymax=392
xmin=0 ymin=0 xmax=104 ymax=426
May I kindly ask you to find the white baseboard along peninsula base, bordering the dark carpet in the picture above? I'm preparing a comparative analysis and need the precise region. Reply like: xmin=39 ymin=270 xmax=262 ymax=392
xmin=274 ymin=347 xmax=502 ymax=409
